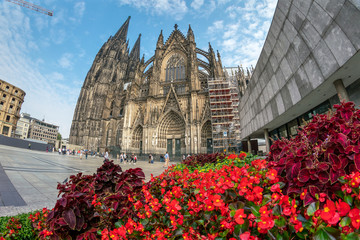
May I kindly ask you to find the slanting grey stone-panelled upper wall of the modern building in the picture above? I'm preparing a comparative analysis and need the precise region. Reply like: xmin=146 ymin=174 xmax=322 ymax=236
xmin=240 ymin=0 xmax=360 ymax=139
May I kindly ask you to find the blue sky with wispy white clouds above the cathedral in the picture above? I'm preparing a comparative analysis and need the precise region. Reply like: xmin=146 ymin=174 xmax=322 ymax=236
xmin=0 ymin=0 xmax=277 ymax=138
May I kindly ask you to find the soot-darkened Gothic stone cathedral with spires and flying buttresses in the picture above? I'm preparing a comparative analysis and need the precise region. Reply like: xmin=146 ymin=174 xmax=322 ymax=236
xmin=70 ymin=17 xmax=224 ymax=155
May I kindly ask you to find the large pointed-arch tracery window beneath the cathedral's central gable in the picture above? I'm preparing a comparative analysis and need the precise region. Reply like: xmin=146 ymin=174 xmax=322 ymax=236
xmin=165 ymin=54 xmax=185 ymax=82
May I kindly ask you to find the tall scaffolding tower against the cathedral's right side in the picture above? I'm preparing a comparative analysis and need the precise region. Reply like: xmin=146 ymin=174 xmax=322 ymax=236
xmin=207 ymin=75 xmax=241 ymax=152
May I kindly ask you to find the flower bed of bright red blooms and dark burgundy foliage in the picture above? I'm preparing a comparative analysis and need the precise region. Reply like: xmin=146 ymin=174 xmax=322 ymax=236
xmin=0 ymin=103 xmax=360 ymax=240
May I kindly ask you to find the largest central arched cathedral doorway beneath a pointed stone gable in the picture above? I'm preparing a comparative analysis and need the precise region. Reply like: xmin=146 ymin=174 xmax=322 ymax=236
xmin=157 ymin=111 xmax=185 ymax=156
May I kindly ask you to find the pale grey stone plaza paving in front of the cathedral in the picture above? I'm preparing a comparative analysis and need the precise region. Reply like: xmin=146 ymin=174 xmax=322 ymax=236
xmin=0 ymin=145 xmax=172 ymax=216
